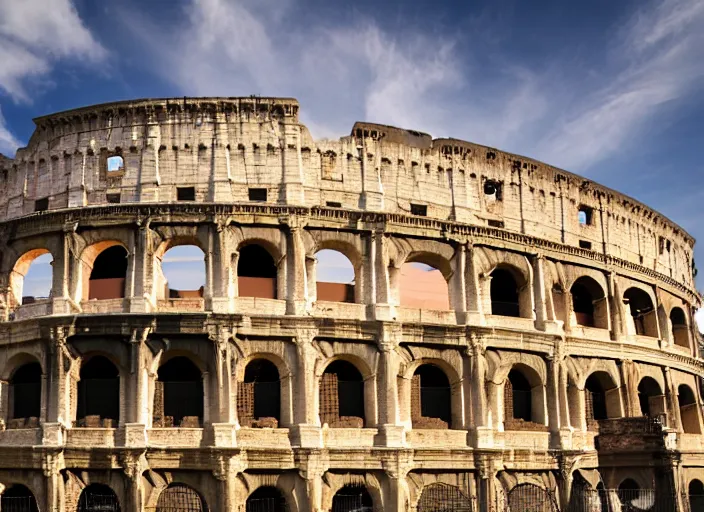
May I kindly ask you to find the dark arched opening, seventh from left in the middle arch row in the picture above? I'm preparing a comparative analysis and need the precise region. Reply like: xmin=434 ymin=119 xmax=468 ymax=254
xmin=504 ymin=363 xmax=545 ymax=430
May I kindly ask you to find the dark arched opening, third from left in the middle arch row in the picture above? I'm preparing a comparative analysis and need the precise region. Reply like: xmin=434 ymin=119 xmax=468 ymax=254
xmin=153 ymin=356 xmax=203 ymax=428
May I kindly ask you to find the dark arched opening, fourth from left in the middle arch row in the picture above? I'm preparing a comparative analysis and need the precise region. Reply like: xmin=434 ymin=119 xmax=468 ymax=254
xmin=237 ymin=359 xmax=281 ymax=428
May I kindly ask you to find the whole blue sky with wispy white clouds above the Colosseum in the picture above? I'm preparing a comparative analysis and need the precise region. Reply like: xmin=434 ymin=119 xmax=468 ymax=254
xmin=0 ymin=0 xmax=704 ymax=316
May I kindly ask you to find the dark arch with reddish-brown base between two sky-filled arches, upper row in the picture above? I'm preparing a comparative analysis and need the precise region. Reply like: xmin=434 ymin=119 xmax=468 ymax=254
xmin=237 ymin=244 xmax=277 ymax=299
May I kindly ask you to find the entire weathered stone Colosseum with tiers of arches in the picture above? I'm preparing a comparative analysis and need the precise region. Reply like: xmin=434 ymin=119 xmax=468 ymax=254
xmin=0 ymin=97 xmax=704 ymax=512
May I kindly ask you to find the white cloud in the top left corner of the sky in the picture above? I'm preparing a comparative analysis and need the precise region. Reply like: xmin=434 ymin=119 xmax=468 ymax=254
xmin=0 ymin=0 xmax=106 ymax=102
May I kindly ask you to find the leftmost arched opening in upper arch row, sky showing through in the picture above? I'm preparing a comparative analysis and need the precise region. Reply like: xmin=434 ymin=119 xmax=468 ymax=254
xmin=10 ymin=249 xmax=53 ymax=305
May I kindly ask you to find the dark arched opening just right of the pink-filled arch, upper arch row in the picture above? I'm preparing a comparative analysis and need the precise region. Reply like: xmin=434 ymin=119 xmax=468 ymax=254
xmin=489 ymin=263 xmax=532 ymax=318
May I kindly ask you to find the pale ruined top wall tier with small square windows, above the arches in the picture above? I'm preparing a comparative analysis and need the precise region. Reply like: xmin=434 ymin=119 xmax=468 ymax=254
xmin=0 ymin=98 xmax=694 ymax=288
